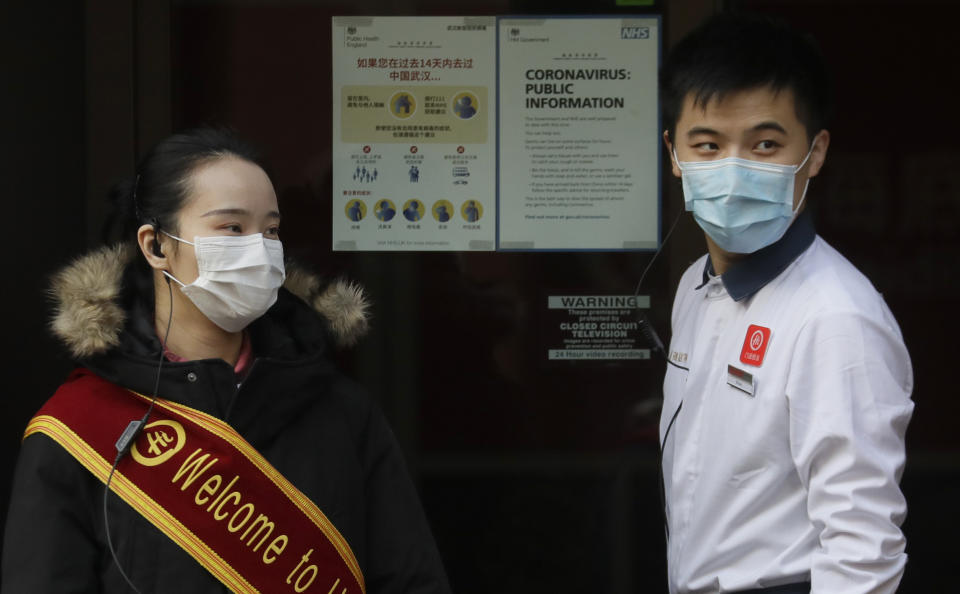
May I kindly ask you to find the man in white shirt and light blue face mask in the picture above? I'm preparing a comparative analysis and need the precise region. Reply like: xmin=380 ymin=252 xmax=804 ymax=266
xmin=660 ymin=14 xmax=913 ymax=594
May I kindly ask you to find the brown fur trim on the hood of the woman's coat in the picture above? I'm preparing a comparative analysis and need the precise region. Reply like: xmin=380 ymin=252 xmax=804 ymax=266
xmin=50 ymin=244 xmax=369 ymax=359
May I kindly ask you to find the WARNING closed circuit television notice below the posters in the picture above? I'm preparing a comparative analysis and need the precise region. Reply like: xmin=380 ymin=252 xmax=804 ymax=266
xmin=547 ymin=295 xmax=650 ymax=361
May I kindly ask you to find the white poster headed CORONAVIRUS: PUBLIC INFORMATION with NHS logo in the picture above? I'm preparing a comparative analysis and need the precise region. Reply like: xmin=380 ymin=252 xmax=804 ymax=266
xmin=498 ymin=18 xmax=662 ymax=250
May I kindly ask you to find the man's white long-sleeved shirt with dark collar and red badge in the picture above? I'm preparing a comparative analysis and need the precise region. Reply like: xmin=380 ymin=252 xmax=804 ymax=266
xmin=660 ymin=214 xmax=913 ymax=594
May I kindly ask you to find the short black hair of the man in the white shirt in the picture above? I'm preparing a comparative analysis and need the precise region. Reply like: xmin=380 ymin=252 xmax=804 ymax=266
xmin=660 ymin=12 xmax=833 ymax=142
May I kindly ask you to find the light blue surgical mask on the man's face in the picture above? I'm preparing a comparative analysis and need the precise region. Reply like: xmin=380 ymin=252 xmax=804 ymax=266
xmin=673 ymin=145 xmax=813 ymax=254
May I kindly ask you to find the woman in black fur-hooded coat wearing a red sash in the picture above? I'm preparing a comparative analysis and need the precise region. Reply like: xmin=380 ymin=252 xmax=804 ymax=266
xmin=3 ymin=129 xmax=449 ymax=594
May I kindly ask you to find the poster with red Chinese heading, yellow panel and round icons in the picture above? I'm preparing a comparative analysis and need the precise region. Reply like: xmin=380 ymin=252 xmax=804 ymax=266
xmin=333 ymin=17 xmax=497 ymax=251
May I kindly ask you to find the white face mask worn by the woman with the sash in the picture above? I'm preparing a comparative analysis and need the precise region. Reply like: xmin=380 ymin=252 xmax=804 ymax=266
xmin=161 ymin=231 xmax=286 ymax=332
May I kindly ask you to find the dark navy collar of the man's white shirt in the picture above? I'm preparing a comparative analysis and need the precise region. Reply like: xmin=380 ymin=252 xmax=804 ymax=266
xmin=697 ymin=210 xmax=817 ymax=301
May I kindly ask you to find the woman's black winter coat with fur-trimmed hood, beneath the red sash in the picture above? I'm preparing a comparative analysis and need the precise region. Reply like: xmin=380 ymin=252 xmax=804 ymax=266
xmin=2 ymin=243 xmax=449 ymax=594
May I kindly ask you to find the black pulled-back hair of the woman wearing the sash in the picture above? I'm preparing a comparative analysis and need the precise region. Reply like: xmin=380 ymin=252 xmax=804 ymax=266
xmin=105 ymin=127 xmax=266 ymax=309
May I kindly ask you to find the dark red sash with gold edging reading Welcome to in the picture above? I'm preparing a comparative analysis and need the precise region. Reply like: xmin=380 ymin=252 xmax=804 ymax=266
xmin=24 ymin=370 xmax=366 ymax=594
